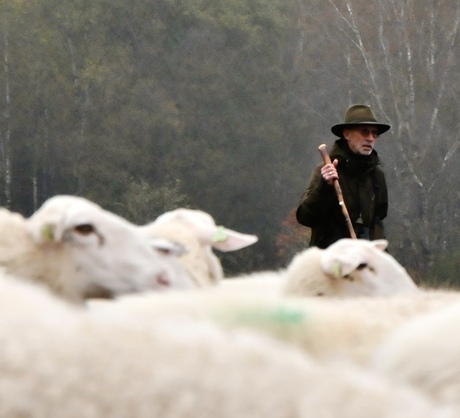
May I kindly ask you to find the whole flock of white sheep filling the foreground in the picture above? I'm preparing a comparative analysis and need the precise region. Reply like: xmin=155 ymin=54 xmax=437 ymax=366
xmin=0 ymin=196 xmax=460 ymax=418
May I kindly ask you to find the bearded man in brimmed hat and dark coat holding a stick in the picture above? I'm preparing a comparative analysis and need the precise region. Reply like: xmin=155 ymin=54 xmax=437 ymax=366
xmin=296 ymin=104 xmax=391 ymax=248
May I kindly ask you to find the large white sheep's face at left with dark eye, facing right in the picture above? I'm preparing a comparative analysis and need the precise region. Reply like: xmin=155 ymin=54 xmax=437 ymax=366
xmin=28 ymin=196 xmax=189 ymax=299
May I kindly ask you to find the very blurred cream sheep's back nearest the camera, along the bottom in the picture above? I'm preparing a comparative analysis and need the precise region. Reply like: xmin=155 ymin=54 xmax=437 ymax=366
xmin=0 ymin=275 xmax=452 ymax=418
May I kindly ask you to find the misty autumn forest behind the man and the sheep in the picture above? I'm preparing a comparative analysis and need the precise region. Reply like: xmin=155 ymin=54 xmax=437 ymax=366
xmin=0 ymin=0 xmax=460 ymax=285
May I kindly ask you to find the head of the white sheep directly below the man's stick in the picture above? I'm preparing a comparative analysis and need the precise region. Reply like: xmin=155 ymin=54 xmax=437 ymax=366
xmin=287 ymin=239 xmax=417 ymax=296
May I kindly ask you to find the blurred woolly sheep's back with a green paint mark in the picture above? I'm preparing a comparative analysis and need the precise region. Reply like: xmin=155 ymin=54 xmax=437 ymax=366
xmin=88 ymin=286 xmax=460 ymax=364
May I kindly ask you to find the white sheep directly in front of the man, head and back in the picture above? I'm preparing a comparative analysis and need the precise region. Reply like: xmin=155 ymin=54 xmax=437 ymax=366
xmin=216 ymin=239 xmax=419 ymax=297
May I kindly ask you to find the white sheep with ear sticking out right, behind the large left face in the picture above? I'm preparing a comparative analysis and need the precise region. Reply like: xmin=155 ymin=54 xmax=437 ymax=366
xmin=140 ymin=208 xmax=258 ymax=287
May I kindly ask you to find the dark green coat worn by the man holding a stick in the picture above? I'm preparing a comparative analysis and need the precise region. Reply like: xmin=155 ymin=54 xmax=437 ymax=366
xmin=296 ymin=139 xmax=388 ymax=248
